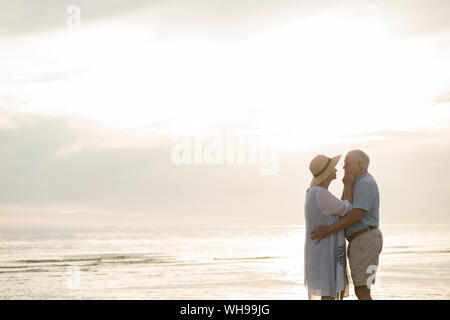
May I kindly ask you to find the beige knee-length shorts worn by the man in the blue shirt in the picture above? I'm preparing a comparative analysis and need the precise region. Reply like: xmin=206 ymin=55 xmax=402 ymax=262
xmin=347 ymin=228 xmax=383 ymax=287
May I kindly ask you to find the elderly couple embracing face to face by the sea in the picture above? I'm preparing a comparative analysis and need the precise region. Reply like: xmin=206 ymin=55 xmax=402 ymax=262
xmin=305 ymin=150 xmax=383 ymax=300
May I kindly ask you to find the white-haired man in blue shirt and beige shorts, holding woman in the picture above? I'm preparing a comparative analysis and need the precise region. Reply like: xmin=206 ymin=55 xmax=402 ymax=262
xmin=311 ymin=150 xmax=383 ymax=300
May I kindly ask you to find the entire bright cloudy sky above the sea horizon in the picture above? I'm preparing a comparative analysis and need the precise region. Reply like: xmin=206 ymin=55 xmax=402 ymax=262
xmin=0 ymin=0 xmax=450 ymax=227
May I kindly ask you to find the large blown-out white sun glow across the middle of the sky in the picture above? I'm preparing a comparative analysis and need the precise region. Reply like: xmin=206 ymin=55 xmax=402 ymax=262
xmin=2 ymin=9 xmax=441 ymax=147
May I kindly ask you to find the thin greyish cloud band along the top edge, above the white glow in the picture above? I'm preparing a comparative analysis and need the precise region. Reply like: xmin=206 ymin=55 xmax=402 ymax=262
xmin=5 ymin=0 xmax=450 ymax=39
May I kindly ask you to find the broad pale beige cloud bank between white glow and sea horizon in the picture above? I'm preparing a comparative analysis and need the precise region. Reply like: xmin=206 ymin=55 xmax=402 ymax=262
xmin=0 ymin=109 xmax=450 ymax=226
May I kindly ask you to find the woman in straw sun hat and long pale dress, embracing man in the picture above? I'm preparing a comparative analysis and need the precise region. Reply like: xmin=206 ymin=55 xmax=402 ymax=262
xmin=305 ymin=155 xmax=352 ymax=300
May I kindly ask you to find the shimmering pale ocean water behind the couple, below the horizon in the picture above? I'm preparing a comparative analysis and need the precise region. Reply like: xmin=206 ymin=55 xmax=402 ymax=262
xmin=0 ymin=225 xmax=450 ymax=300
